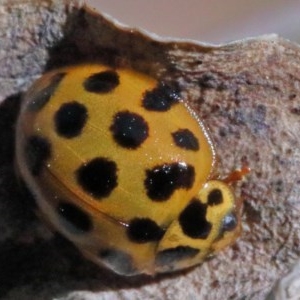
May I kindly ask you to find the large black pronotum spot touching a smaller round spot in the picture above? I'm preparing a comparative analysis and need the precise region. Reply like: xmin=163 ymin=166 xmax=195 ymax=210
xmin=179 ymin=199 xmax=212 ymax=239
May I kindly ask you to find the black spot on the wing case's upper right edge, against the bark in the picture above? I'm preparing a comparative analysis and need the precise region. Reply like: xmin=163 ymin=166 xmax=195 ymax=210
xmin=143 ymin=83 xmax=180 ymax=111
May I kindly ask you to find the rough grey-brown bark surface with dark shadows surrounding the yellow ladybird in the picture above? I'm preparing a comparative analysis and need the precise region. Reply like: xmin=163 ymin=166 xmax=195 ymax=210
xmin=0 ymin=0 xmax=300 ymax=300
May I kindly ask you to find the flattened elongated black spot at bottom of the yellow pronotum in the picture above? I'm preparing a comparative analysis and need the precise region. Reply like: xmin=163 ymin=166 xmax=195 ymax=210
xmin=155 ymin=246 xmax=200 ymax=266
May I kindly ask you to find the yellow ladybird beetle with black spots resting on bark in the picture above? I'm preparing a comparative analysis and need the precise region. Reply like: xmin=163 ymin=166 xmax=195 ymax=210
xmin=16 ymin=64 xmax=246 ymax=275
